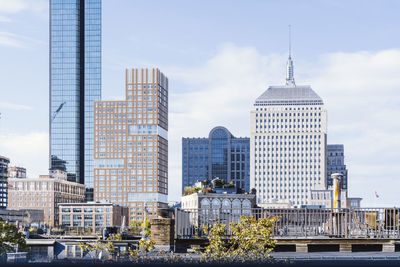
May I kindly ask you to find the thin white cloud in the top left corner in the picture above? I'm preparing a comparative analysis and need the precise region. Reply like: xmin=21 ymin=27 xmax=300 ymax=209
xmin=0 ymin=0 xmax=48 ymax=14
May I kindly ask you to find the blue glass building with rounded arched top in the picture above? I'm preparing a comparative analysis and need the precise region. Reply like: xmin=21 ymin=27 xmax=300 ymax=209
xmin=182 ymin=126 xmax=250 ymax=192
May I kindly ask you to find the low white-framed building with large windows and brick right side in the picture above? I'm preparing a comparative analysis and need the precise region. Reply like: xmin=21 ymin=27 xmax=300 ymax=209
xmin=58 ymin=202 xmax=129 ymax=232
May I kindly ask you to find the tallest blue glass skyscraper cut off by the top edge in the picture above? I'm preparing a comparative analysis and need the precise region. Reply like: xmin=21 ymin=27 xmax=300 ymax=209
xmin=49 ymin=0 xmax=101 ymax=200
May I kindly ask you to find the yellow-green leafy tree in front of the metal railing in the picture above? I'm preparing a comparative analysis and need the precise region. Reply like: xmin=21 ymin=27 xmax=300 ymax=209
xmin=201 ymin=216 xmax=277 ymax=262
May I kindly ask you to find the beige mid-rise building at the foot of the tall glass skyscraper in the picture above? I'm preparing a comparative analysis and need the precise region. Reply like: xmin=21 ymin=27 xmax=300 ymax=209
xmin=8 ymin=171 xmax=85 ymax=226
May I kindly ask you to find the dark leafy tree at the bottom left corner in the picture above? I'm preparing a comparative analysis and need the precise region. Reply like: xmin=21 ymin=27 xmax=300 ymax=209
xmin=0 ymin=218 xmax=26 ymax=258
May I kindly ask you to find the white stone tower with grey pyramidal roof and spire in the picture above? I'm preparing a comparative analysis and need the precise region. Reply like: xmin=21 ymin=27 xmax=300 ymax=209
xmin=250 ymin=56 xmax=327 ymax=206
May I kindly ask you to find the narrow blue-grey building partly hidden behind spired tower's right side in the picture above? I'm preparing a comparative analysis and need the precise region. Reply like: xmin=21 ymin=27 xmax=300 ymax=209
xmin=326 ymin=145 xmax=347 ymax=189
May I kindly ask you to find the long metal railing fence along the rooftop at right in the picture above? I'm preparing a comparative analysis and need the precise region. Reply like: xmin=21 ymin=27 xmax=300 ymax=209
xmin=175 ymin=208 xmax=400 ymax=239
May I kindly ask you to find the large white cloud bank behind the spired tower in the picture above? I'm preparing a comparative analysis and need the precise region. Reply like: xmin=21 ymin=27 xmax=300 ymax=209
xmin=162 ymin=44 xmax=400 ymax=206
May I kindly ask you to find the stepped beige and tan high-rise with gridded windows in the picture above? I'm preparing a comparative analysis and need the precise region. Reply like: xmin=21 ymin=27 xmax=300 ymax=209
xmin=94 ymin=69 xmax=168 ymax=221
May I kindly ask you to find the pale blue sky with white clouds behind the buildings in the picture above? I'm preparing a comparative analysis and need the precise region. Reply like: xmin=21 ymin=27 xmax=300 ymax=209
xmin=0 ymin=0 xmax=400 ymax=207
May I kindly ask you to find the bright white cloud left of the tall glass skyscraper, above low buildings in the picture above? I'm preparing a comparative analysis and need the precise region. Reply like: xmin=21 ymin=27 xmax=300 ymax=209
xmin=0 ymin=132 xmax=49 ymax=177
